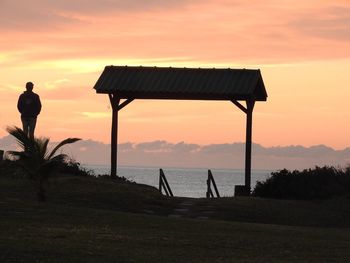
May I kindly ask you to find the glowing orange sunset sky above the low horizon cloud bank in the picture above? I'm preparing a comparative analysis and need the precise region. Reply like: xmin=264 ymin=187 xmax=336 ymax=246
xmin=0 ymin=0 xmax=350 ymax=149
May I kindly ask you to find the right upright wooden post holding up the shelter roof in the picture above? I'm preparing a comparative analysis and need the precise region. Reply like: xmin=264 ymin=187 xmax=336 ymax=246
xmin=245 ymin=100 xmax=255 ymax=195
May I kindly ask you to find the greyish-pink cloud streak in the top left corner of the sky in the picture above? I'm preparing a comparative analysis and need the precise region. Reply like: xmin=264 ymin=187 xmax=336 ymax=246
xmin=0 ymin=0 xmax=194 ymax=31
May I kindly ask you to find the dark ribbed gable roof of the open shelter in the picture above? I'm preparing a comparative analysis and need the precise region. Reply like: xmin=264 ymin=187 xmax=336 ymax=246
xmin=94 ymin=66 xmax=267 ymax=101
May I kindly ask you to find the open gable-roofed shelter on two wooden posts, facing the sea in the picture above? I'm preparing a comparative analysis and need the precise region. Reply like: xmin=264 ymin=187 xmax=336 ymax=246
xmin=94 ymin=66 xmax=267 ymax=193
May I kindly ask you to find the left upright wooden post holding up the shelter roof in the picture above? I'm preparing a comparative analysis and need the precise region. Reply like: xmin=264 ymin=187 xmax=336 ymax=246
xmin=108 ymin=94 xmax=120 ymax=179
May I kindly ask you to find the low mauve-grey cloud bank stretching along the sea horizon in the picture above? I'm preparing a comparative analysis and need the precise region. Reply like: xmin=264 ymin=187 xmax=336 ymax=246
xmin=0 ymin=136 xmax=350 ymax=170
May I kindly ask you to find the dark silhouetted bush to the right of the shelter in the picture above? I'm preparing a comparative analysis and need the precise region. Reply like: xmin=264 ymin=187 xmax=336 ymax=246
xmin=253 ymin=166 xmax=350 ymax=200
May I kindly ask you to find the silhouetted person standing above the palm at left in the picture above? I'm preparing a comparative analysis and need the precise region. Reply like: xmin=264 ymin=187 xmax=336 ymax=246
xmin=17 ymin=82 xmax=41 ymax=138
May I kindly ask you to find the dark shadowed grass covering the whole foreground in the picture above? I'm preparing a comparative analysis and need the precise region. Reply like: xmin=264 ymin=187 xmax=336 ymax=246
xmin=0 ymin=172 xmax=350 ymax=262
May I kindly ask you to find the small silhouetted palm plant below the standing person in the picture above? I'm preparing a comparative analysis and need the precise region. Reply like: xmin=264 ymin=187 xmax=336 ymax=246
xmin=6 ymin=126 xmax=80 ymax=202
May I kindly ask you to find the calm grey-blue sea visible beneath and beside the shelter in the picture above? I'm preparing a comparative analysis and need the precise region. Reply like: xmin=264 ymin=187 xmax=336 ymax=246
xmin=84 ymin=165 xmax=271 ymax=197
